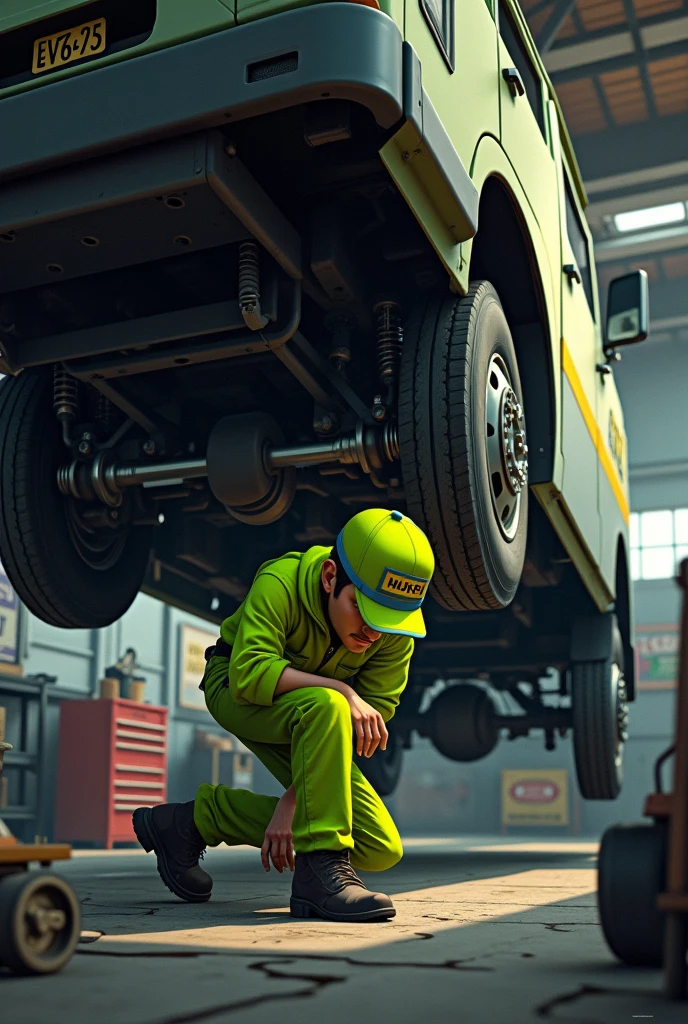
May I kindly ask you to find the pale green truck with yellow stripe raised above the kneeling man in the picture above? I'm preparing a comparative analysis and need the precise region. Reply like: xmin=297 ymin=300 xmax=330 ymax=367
xmin=0 ymin=0 xmax=647 ymax=799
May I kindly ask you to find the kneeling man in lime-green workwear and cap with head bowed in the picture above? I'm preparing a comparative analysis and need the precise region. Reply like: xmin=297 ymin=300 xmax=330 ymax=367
xmin=133 ymin=509 xmax=434 ymax=922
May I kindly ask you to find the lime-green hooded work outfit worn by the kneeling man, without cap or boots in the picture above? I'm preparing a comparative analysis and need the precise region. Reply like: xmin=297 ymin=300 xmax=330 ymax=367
xmin=195 ymin=547 xmax=414 ymax=871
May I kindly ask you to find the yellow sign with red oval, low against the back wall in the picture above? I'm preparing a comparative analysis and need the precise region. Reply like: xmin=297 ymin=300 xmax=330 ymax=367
xmin=502 ymin=768 xmax=568 ymax=826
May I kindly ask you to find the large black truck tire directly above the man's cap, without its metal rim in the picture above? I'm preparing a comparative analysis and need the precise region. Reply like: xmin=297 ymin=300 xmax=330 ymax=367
xmin=399 ymin=282 xmax=528 ymax=610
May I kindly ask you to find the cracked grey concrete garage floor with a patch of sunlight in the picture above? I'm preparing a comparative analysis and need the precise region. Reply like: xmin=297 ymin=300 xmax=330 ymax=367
xmin=0 ymin=838 xmax=688 ymax=1024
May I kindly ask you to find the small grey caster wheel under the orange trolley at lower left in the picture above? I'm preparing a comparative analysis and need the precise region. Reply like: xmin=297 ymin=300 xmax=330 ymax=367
xmin=0 ymin=871 xmax=81 ymax=974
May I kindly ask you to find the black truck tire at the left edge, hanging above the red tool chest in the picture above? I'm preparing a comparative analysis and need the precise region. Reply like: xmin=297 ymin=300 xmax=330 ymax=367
xmin=0 ymin=370 xmax=152 ymax=629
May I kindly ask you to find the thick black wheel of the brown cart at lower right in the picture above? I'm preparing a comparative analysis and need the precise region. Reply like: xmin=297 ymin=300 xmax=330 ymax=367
xmin=597 ymin=821 xmax=668 ymax=967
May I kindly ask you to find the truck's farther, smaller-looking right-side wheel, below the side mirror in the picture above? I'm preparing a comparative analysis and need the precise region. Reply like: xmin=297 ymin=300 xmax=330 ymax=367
xmin=571 ymin=630 xmax=624 ymax=800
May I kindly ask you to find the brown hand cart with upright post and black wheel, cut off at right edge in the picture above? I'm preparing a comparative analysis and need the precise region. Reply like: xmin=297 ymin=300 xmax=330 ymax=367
xmin=598 ymin=559 xmax=688 ymax=999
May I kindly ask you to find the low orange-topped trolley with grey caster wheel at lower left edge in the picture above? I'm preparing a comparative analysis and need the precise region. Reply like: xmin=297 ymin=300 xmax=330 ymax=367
xmin=0 ymin=708 xmax=81 ymax=974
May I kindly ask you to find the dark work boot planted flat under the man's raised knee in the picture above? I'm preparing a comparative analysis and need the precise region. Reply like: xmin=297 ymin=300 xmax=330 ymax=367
xmin=290 ymin=850 xmax=396 ymax=921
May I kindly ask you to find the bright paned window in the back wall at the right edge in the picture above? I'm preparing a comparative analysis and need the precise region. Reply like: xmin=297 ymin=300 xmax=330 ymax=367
xmin=631 ymin=509 xmax=688 ymax=580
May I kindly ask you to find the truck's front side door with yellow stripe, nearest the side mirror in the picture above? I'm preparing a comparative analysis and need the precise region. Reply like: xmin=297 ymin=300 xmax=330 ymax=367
xmin=560 ymin=161 xmax=601 ymax=564
